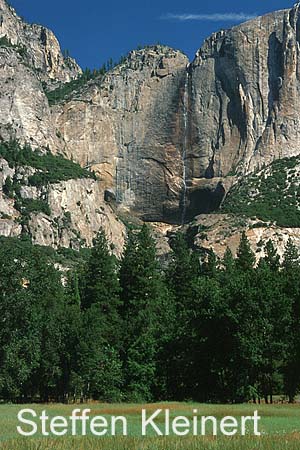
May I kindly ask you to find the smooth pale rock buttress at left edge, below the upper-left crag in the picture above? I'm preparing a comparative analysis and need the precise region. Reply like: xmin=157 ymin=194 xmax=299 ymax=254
xmin=0 ymin=47 xmax=60 ymax=152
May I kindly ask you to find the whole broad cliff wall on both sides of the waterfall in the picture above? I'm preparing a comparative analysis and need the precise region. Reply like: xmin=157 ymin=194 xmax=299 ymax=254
xmin=55 ymin=5 xmax=300 ymax=222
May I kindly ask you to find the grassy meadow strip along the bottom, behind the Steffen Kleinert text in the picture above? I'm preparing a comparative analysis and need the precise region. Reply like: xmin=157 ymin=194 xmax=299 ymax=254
xmin=0 ymin=403 xmax=300 ymax=450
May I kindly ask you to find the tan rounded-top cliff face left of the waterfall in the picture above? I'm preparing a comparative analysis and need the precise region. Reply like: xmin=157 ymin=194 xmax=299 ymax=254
xmin=53 ymin=46 xmax=188 ymax=220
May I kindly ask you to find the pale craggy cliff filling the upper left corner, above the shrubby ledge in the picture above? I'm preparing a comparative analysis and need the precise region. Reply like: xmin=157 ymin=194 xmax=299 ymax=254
xmin=0 ymin=0 xmax=81 ymax=152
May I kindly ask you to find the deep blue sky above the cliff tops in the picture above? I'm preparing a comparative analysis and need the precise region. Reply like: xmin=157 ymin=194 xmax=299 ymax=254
xmin=9 ymin=0 xmax=294 ymax=68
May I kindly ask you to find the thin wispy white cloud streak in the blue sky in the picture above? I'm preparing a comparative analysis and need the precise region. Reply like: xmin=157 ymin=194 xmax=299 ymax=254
xmin=161 ymin=12 xmax=257 ymax=22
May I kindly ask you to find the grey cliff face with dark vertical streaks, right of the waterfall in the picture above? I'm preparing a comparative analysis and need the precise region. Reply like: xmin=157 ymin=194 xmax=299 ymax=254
xmin=190 ymin=4 xmax=300 ymax=178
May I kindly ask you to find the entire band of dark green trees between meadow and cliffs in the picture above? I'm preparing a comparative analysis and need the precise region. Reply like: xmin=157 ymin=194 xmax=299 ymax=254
xmin=0 ymin=225 xmax=300 ymax=403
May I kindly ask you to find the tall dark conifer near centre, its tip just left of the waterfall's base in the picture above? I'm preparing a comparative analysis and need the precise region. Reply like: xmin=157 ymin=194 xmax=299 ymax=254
xmin=120 ymin=225 xmax=164 ymax=401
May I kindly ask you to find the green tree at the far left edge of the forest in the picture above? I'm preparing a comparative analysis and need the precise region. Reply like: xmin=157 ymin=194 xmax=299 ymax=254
xmin=0 ymin=241 xmax=41 ymax=402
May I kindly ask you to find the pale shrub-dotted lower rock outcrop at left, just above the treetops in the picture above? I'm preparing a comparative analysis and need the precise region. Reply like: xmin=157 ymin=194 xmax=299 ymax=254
xmin=0 ymin=159 xmax=126 ymax=256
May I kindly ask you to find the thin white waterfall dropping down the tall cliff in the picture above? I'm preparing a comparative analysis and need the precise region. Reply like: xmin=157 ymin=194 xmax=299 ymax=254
xmin=181 ymin=66 xmax=190 ymax=225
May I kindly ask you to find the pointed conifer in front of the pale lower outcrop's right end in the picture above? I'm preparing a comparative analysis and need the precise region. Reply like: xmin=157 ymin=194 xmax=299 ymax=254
xmin=77 ymin=230 xmax=122 ymax=400
